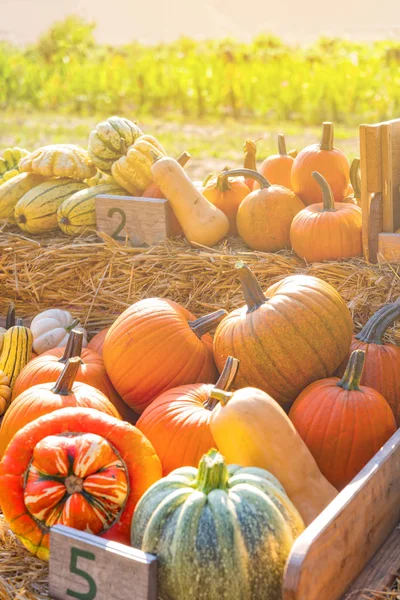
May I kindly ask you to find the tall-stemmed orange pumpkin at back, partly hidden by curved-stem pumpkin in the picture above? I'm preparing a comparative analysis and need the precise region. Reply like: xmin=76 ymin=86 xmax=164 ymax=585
xmin=291 ymin=123 xmax=350 ymax=206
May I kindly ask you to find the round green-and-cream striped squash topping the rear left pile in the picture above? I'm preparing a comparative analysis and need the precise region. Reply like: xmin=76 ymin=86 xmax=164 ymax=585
xmin=88 ymin=117 xmax=143 ymax=173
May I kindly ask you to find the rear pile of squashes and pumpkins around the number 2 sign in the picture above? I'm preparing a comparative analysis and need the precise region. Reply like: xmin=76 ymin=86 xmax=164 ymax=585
xmin=0 ymin=117 xmax=362 ymax=262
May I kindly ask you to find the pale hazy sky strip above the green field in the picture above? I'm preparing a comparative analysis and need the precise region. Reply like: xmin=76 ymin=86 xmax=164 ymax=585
xmin=0 ymin=0 xmax=400 ymax=44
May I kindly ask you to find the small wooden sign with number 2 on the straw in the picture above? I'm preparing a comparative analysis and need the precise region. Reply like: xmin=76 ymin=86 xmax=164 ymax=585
xmin=95 ymin=194 xmax=173 ymax=246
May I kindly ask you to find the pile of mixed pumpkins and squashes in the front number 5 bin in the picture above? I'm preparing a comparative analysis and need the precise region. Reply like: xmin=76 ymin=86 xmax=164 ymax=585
xmin=0 ymin=262 xmax=400 ymax=600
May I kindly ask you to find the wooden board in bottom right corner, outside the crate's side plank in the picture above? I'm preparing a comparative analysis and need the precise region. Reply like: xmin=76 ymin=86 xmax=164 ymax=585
xmin=343 ymin=526 xmax=400 ymax=600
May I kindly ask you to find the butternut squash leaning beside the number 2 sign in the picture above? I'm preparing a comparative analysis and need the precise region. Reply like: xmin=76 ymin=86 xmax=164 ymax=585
xmin=151 ymin=157 xmax=229 ymax=246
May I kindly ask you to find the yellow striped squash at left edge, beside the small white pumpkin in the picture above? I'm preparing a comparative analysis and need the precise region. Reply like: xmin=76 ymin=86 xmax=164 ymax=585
xmin=0 ymin=325 xmax=33 ymax=398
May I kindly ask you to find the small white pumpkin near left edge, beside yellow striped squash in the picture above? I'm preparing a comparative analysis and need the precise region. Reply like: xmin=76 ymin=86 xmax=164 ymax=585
xmin=30 ymin=308 xmax=87 ymax=354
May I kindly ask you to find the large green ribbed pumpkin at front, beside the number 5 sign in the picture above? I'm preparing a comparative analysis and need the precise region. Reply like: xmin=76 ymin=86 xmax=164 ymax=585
xmin=131 ymin=450 xmax=304 ymax=600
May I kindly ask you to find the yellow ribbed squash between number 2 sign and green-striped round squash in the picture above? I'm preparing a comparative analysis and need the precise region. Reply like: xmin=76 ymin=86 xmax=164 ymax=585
xmin=111 ymin=135 xmax=165 ymax=196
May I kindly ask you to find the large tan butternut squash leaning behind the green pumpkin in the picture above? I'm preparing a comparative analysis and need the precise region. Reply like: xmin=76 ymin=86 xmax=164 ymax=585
xmin=210 ymin=388 xmax=338 ymax=525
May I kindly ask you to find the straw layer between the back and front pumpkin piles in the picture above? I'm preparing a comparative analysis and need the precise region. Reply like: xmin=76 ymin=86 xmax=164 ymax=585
xmin=0 ymin=225 xmax=400 ymax=343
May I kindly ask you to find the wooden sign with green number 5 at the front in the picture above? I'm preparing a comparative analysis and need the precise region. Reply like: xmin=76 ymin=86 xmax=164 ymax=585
xmin=49 ymin=525 xmax=157 ymax=600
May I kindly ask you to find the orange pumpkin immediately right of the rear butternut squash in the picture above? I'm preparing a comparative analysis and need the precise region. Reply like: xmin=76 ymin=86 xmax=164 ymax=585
xmin=203 ymin=168 xmax=250 ymax=237
